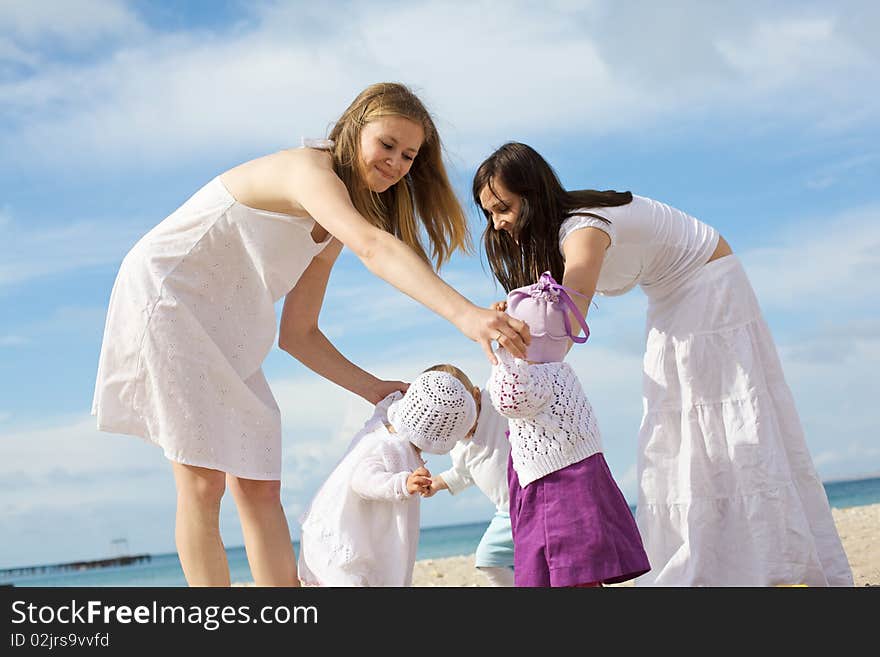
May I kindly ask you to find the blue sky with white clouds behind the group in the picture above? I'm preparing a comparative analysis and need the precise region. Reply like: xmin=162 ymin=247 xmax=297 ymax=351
xmin=0 ymin=0 xmax=880 ymax=567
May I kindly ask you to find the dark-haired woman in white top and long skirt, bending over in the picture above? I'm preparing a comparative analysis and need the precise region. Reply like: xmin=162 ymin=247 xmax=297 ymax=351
xmin=473 ymin=143 xmax=853 ymax=586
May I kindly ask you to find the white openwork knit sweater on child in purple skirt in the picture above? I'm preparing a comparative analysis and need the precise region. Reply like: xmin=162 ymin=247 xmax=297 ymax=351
xmin=488 ymin=349 xmax=602 ymax=488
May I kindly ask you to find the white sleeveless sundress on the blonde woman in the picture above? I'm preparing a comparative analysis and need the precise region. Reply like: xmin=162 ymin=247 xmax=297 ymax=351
xmin=92 ymin=177 xmax=332 ymax=480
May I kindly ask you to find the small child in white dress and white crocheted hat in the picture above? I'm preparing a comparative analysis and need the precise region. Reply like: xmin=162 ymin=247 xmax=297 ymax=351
xmin=298 ymin=365 xmax=478 ymax=586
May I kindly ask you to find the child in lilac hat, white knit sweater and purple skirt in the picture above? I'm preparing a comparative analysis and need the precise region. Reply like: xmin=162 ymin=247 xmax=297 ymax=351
xmin=488 ymin=272 xmax=650 ymax=586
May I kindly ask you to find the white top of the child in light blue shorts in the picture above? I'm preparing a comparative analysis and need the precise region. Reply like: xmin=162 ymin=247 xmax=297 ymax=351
xmin=440 ymin=390 xmax=510 ymax=512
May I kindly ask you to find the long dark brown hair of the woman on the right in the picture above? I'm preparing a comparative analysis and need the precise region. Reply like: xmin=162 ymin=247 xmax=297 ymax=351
xmin=473 ymin=142 xmax=632 ymax=292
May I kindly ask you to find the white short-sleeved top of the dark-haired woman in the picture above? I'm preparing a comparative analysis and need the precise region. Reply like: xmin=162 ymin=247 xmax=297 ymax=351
xmin=559 ymin=194 xmax=718 ymax=298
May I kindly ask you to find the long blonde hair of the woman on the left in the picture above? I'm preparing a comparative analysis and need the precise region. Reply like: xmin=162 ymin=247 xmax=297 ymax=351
xmin=329 ymin=82 xmax=473 ymax=270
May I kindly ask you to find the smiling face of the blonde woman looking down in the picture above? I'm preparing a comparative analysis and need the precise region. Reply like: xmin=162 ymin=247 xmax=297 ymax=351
xmin=360 ymin=116 xmax=425 ymax=193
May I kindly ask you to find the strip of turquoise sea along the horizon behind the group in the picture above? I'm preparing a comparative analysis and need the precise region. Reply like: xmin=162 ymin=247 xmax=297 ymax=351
xmin=0 ymin=477 xmax=880 ymax=587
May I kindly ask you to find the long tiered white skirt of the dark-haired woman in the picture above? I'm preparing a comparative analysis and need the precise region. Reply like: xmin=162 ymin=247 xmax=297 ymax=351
xmin=636 ymin=255 xmax=853 ymax=586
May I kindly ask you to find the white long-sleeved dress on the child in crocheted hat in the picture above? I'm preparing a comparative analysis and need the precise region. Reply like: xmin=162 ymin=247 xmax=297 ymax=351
xmin=298 ymin=392 xmax=424 ymax=586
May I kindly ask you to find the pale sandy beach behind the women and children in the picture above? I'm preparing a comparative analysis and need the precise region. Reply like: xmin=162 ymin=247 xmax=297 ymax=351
xmin=413 ymin=504 xmax=880 ymax=586
